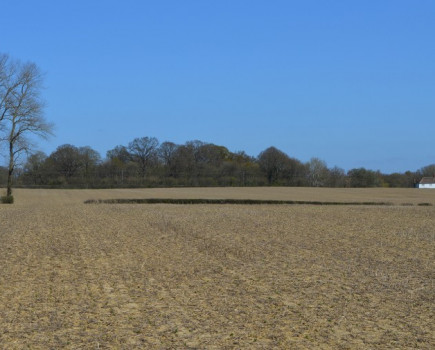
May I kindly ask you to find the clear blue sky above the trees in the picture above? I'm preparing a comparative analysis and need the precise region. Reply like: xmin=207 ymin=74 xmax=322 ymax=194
xmin=0 ymin=0 xmax=435 ymax=173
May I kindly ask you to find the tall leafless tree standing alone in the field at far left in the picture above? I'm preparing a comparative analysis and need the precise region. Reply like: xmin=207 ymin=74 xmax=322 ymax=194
xmin=0 ymin=56 xmax=53 ymax=197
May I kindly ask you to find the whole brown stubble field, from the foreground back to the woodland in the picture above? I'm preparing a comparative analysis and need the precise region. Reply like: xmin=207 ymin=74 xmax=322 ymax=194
xmin=0 ymin=187 xmax=435 ymax=349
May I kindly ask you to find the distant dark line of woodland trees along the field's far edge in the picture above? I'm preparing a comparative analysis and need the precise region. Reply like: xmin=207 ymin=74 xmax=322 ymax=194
xmin=0 ymin=137 xmax=435 ymax=188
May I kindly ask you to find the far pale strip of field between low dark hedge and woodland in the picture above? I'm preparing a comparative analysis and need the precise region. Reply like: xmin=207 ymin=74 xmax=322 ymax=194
xmin=9 ymin=187 xmax=435 ymax=206
